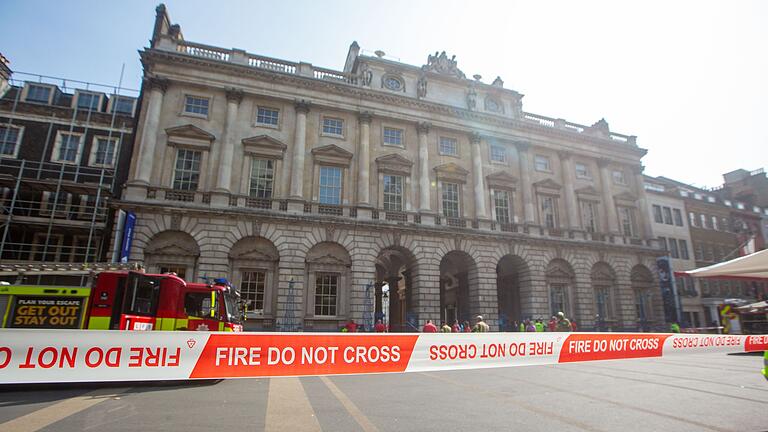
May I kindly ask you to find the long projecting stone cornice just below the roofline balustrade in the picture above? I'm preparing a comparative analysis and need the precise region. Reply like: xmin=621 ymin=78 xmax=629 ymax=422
xmin=140 ymin=49 xmax=647 ymax=157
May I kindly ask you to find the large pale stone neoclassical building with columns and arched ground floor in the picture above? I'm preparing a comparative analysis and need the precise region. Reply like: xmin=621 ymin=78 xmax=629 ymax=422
xmin=118 ymin=5 xmax=663 ymax=331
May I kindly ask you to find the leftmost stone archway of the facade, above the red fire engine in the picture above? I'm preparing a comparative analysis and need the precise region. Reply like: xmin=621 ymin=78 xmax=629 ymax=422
xmin=144 ymin=231 xmax=200 ymax=282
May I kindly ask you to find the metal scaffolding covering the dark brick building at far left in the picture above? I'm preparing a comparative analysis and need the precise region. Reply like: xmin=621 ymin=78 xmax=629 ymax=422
xmin=0 ymin=72 xmax=138 ymax=285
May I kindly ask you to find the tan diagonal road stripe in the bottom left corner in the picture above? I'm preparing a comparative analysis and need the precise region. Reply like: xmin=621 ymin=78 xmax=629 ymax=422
xmin=0 ymin=389 xmax=128 ymax=432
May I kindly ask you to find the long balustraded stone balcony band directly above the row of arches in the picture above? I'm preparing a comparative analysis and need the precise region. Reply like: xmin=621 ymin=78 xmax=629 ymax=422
xmin=134 ymin=186 xmax=661 ymax=249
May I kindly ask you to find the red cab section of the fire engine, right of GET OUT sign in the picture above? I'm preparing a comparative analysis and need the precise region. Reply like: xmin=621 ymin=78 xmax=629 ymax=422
xmin=86 ymin=271 xmax=243 ymax=332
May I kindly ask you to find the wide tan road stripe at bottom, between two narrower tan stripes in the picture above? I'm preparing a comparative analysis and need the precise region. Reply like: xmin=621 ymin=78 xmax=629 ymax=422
xmin=264 ymin=378 xmax=322 ymax=432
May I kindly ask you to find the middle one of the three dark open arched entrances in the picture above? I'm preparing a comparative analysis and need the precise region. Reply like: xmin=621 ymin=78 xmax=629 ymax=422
xmin=440 ymin=251 xmax=477 ymax=324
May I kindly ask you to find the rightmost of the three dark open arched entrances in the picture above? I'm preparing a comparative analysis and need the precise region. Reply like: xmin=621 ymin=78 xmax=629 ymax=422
xmin=496 ymin=255 xmax=528 ymax=331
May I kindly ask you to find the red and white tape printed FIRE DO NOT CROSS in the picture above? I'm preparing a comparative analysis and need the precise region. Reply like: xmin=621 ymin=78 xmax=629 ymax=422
xmin=0 ymin=329 xmax=768 ymax=384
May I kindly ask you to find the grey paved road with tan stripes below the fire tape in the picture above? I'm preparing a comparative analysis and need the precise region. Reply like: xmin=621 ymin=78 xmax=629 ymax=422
xmin=0 ymin=354 xmax=768 ymax=432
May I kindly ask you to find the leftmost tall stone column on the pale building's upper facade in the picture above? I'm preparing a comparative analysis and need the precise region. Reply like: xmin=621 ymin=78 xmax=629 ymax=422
xmin=135 ymin=78 xmax=168 ymax=185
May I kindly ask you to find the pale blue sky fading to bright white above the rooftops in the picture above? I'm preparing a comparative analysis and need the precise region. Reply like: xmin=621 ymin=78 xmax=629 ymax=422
xmin=0 ymin=0 xmax=768 ymax=187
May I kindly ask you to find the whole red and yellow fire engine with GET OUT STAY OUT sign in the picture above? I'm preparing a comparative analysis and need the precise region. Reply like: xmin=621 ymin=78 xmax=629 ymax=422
xmin=0 ymin=266 xmax=243 ymax=332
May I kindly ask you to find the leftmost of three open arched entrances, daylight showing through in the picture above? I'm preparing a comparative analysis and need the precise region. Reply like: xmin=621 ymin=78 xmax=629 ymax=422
xmin=373 ymin=247 xmax=419 ymax=332
